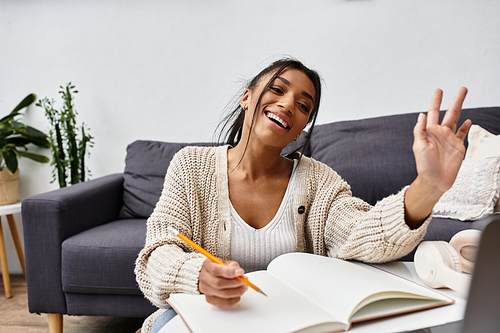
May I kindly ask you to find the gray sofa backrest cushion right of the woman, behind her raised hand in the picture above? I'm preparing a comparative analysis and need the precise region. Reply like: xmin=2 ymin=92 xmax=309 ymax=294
xmin=308 ymin=107 xmax=500 ymax=205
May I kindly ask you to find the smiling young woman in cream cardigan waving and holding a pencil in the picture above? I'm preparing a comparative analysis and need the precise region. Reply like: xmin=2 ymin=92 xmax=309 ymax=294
xmin=136 ymin=59 xmax=471 ymax=332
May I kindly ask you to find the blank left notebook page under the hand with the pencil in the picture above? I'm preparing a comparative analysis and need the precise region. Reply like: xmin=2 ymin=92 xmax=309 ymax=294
xmin=171 ymin=271 xmax=347 ymax=333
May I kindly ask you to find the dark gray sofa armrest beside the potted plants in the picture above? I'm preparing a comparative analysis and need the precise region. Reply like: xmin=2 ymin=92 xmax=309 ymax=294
xmin=21 ymin=174 xmax=123 ymax=313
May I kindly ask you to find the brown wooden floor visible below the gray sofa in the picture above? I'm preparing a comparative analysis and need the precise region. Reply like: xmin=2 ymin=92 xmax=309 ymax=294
xmin=0 ymin=275 xmax=144 ymax=333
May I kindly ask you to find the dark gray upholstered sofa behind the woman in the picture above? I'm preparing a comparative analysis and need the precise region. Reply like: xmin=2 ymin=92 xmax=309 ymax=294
xmin=22 ymin=107 xmax=500 ymax=324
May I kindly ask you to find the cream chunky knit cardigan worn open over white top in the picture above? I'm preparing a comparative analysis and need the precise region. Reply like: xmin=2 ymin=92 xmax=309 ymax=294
xmin=135 ymin=146 xmax=430 ymax=332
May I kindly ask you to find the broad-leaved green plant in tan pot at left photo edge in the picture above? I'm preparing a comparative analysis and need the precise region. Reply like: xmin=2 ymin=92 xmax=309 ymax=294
xmin=0 ymin=94 xmax=50 ymax=205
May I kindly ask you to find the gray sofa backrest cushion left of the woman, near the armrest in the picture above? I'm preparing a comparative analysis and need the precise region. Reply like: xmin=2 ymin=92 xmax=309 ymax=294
xmin=120 ymin=140 xmax=211 ymax=218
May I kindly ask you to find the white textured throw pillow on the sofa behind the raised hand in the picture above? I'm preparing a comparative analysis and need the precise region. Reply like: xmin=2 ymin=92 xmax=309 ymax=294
xmin=433 ymin=156 xmax=500 ymax=221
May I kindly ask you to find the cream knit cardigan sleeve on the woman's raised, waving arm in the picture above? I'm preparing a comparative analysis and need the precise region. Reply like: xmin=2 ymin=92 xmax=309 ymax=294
xmin=308 ymin=161 xmax=430 ymax=263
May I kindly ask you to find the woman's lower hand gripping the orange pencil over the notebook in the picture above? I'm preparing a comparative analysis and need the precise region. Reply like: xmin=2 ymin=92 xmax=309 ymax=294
xmin=198 ymin=259 xmax=248 ymax=306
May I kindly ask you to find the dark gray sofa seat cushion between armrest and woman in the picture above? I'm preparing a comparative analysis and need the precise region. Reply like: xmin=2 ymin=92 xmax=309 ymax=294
xmin=61 ymin=219 xmax=146 ymax=295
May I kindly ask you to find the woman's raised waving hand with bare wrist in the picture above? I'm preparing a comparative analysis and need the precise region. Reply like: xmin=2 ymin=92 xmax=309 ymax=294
xmin=405 ymin=87 xmax=472 ymax=228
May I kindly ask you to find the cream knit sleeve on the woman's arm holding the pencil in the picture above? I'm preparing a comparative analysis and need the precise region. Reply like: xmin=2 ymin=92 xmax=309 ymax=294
xmin=135 ymin=150 xmax=205 ymax=308
